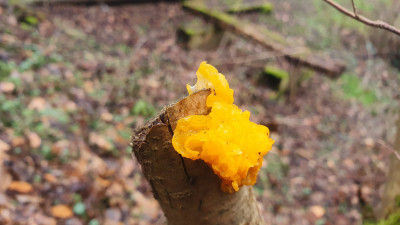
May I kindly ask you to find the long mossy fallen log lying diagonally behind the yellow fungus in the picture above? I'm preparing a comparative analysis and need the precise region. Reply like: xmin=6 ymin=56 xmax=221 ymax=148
xmin=183 ymin=1 xmax=346 ymax=77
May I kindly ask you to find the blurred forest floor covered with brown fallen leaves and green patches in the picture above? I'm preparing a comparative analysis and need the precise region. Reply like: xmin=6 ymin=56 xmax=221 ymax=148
xmin=0 ymin=0 xmax=400 ymax=225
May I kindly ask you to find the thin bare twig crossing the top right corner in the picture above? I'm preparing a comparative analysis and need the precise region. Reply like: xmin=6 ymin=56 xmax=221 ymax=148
xmin=323 ymin=0 xmax=400 ymax=36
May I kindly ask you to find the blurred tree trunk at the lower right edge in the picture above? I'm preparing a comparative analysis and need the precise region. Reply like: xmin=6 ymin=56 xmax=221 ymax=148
xmin=378 ymin=116 xmax=400 ymax=219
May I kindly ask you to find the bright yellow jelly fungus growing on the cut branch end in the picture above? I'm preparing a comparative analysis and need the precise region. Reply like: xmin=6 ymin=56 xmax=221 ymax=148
xmin=172 ymin=62 xmax=274 ymax=192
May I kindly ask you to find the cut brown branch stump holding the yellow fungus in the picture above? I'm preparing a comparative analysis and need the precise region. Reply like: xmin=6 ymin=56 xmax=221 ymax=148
xmin=131 ymin=90 xmax=264 ymax=225
